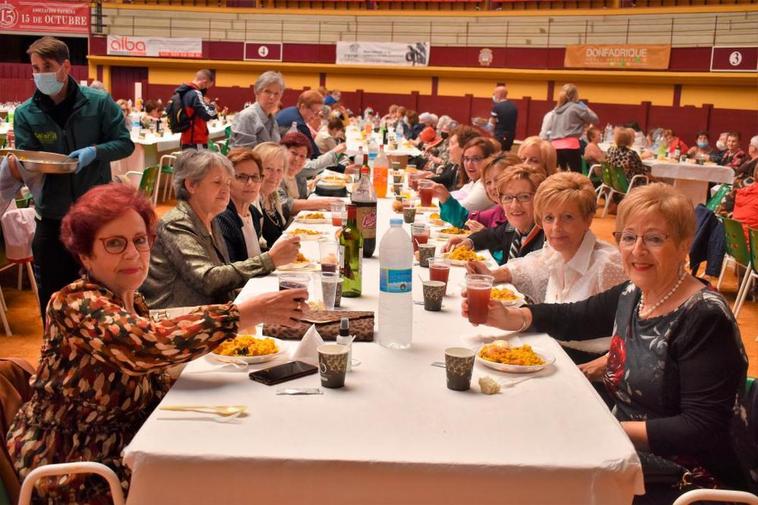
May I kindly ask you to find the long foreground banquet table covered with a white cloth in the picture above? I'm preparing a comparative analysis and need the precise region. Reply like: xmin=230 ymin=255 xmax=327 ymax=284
xmin=124 ymin=200 xmax=643 ymax=505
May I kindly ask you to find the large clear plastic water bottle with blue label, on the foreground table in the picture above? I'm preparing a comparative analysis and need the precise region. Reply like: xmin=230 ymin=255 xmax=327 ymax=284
xmin=377 ymin=217 xmax=413 ymax=349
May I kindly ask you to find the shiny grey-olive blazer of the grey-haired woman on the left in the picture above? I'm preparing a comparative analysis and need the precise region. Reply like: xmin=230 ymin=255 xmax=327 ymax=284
xmin=140 ymin=200 xmax=274 ymax=309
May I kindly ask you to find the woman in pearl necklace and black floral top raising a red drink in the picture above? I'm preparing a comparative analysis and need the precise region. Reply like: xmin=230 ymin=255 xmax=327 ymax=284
xmin=463 ymin=184 xmax=747 ymax=503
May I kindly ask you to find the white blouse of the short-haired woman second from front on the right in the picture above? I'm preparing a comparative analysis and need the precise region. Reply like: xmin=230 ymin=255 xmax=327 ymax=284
xmin=505 ymin=230 xmax=627 ymax=353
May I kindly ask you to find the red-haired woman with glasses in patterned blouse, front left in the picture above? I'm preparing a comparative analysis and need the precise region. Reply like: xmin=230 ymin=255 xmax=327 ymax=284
xmin=8 ymin=184 xmax=307 ymax=505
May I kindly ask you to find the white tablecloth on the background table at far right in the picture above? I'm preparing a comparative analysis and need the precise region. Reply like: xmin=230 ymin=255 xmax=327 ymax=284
xmin=643 ymin=160 xmax=734 ymax=205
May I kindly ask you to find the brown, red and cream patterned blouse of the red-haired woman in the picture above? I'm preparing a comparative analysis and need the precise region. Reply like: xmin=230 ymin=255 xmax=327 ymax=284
xmin=8 ymin=279 xmax=239 ymax=505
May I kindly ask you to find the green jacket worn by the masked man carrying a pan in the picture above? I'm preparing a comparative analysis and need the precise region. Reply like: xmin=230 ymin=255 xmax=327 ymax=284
xmin=13 ymin=77 xmax=134 ymax=219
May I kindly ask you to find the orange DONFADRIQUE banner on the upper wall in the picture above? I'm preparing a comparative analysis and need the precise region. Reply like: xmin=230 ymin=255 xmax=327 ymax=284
xmin=563 ymin=44 xmax=671 ymax=70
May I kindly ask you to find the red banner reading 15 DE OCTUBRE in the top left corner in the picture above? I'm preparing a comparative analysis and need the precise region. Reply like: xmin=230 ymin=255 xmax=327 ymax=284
xmin=0 ymin=0 xmax=90 ymax=36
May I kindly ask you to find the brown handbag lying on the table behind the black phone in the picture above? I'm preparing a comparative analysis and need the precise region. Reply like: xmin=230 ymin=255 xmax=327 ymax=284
xmin=263 ymin=310 xmax=374 ymax=342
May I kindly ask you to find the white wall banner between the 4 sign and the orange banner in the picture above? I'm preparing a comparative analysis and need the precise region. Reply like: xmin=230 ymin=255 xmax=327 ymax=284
xmin=337 ymin=42 xmax=431 ymax=67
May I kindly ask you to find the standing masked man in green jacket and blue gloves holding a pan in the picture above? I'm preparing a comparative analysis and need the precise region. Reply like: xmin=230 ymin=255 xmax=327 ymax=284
xmin=13 ymin=37 xmax=134 ymax=321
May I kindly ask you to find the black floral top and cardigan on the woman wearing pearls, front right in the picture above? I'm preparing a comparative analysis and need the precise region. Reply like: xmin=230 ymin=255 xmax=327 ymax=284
xmin=528 ymin=282 xmax=747 ymax=485
